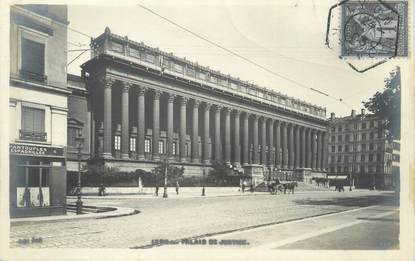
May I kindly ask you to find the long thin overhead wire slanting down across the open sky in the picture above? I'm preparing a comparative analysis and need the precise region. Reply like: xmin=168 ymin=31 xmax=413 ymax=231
xmin=138 ymin=4 xmax=348 ymax=106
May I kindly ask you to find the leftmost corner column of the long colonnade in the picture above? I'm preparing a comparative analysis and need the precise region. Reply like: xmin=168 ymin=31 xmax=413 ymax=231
xmin=102 ymin=77 xmax=114 ymax=158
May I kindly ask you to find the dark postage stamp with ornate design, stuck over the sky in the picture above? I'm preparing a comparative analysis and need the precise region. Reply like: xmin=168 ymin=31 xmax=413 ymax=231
xmin=341 ymin=1 xmax=408 ymax=58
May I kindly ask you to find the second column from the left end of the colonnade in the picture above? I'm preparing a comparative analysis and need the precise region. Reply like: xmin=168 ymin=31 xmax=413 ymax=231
xmin=121 ymin=82 xmax=131 ymax=159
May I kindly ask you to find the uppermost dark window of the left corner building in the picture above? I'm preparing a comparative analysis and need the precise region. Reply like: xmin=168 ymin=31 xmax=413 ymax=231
xmin=21 ymin=37 xmax=45 ymax=81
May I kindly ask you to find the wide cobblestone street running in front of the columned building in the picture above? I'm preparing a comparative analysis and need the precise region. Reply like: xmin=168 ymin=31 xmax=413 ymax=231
xmin=10 ymin=191 xmax=399 ymax=248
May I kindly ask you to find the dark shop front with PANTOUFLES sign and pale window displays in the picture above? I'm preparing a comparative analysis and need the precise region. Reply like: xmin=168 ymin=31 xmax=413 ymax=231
xmin=9 ymin=143 xmax=66 ymax=218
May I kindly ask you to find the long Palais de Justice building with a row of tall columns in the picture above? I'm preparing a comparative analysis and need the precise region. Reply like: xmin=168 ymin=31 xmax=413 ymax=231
xmin=82 ymin=28 xmax=328 ymax=181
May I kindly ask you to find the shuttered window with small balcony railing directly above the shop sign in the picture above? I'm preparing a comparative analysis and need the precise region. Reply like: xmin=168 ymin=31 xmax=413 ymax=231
xmin=20 ymin=106 xmax=46 ymax=141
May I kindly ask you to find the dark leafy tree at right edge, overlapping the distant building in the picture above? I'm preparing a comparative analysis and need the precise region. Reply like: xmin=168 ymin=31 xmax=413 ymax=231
xmin=363 ymin=67 xmax=401 ymax=139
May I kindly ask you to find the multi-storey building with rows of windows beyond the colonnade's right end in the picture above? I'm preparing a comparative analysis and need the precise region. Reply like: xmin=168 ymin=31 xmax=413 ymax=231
xmin=327 ymin=109 xmax=400 ymax=189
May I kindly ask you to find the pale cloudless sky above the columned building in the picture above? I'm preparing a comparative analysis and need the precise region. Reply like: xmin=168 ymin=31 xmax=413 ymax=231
xmin=68 ymin=0 xmax=405 ymax=117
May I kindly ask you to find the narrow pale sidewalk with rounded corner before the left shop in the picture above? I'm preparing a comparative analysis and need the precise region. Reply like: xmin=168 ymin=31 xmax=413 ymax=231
xmin=10 ymin=207 xmax=137 ymax=225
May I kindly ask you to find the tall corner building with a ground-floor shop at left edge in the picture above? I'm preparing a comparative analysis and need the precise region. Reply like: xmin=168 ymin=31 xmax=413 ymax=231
xmin=9 ymin=5 xmax=70 ymax=217
